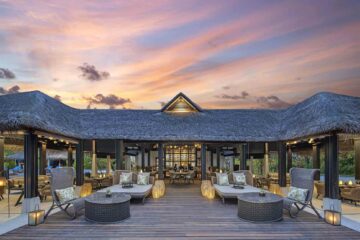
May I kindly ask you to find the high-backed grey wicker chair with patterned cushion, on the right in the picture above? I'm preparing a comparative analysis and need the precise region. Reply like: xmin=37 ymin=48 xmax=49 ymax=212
xmin=283 ymin=168 xmax=321 ymax=218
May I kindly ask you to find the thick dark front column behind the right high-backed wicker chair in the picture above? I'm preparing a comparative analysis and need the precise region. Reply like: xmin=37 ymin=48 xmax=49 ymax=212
xmin=324 ymin=134 xmax=339 ymax=199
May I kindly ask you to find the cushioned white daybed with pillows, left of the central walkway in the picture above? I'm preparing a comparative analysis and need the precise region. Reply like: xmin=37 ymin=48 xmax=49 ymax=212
xmin=98 ymin=170 xmax=155 ymax=204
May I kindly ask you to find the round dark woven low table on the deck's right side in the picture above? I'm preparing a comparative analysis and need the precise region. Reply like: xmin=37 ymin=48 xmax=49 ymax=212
xmin=238 ymin=192 xmax=283 ymax=222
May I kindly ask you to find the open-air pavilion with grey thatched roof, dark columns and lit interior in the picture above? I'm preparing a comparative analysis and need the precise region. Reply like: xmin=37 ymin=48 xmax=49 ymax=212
xmin=0 ymin=91 xmax=360 ymax=237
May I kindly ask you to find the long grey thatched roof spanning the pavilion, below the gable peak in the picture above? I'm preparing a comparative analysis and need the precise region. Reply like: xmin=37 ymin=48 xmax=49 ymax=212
xmin=0 ymin=91 xmax=360 ymax=142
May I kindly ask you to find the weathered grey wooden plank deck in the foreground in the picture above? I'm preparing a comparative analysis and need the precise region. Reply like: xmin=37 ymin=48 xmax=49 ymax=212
xmin=0 ymin=182 xmax=360 ymax=240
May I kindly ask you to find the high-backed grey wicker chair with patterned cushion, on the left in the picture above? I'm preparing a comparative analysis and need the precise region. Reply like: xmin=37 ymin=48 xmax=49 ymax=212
xmin=45 ymin=167 xmax=85 ymax=219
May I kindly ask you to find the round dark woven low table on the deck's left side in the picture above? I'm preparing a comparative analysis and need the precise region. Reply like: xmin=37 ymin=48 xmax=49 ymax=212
xmin=85 ymin=192 xmax=131 ymax=223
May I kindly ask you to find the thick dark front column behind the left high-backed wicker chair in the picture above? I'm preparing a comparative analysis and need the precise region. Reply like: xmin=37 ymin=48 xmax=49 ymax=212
xmin=24 ymin=132 xmax=38 ymax=198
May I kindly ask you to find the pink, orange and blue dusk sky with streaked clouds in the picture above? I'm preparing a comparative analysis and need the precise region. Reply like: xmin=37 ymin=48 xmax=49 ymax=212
xmin=0 ymin=0 xmax=360 ymax=109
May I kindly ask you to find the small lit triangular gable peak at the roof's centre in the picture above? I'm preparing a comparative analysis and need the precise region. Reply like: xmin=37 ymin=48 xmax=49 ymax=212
xmin=161 ymin=92 xmax=202 ymax=113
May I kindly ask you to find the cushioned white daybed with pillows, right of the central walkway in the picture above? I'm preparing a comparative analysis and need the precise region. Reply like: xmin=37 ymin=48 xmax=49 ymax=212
xmin=211 ymin=170 xmax=260 ymax=203
